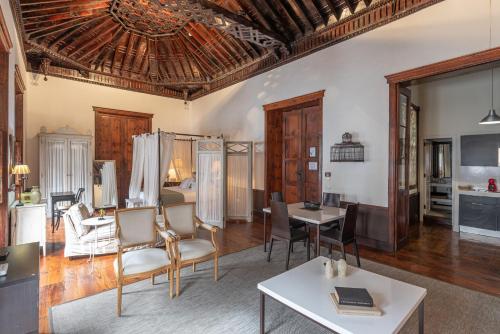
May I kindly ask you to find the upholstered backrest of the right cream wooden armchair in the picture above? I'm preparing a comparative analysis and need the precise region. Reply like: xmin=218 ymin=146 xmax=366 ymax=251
xmin=163 ymin=203 xmax=196 ymax=237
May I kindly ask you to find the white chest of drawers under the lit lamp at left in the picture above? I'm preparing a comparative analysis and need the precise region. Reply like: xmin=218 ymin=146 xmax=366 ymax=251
xmin=11 ymin=204 xmax=47 ymax=256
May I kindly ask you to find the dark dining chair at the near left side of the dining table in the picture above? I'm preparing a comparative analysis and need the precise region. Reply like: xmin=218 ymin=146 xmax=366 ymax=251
xmin=267 ymin=201 xmax=311 ymax=270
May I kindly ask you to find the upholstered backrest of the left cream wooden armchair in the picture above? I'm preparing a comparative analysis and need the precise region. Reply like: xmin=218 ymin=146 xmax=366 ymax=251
xmin=115 ymin=207 xmax=156 ymax=248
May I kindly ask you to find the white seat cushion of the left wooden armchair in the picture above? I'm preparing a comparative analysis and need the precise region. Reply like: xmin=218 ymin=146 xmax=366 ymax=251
xmin=113 ymin=248 xmax=170 ymax=275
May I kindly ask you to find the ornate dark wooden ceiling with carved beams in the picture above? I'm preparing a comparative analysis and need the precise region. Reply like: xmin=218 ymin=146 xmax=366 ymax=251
xmin=11 ymin=0 xmax=443 ymax=100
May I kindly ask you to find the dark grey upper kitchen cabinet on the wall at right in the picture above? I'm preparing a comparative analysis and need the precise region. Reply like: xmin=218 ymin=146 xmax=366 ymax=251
xmin=460 ymin=134 xmax=500 ymax=167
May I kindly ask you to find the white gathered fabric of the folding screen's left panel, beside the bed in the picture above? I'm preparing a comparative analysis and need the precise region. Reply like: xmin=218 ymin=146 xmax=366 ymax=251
xmin=197 ymin=153 xmax=224 ymax=224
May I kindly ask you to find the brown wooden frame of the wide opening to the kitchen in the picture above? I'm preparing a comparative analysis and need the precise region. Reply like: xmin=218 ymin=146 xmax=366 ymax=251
xmin=385 ymin=47 xmax=500 ymax=251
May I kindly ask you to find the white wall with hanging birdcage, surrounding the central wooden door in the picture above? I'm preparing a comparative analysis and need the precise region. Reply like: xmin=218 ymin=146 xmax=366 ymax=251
xmin=192 ymin=0 xmax=500 ymax=206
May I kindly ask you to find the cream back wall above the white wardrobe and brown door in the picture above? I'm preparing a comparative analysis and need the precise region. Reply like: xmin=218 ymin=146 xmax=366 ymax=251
xmin=25 ymin=73 xmax=191 ymax=185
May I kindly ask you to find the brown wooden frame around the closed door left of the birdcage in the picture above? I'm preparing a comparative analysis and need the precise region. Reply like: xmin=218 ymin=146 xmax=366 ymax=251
xmin=262 ymin=90 xmax=325 ymax=206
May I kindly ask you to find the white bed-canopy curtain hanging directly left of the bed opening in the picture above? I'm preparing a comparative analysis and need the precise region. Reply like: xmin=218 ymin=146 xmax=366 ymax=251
xmin=144 ymin=132 xmax=175 ymax=206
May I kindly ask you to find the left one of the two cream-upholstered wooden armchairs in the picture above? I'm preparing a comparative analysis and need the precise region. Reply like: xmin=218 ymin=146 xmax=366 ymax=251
xmin=113 ymin=207 xmax=175 ymax=316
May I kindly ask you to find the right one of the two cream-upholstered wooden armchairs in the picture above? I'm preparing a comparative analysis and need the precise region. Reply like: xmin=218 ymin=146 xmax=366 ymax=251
xmin=163 ymin=203 xmax=219 ymax=295
